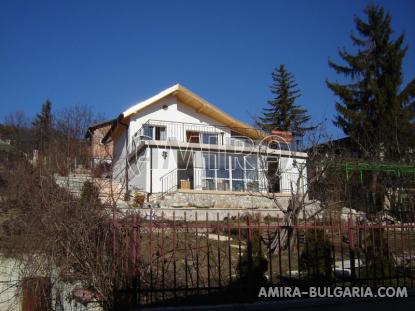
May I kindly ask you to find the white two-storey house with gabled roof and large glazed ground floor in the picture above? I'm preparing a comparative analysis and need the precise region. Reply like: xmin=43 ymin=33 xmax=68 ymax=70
xmin=102 ymin=84 xmax=307 ymax=199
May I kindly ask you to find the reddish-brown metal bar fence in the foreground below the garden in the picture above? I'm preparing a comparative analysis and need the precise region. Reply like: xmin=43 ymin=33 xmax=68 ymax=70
xmin=113 ymin=213 xmax=415 ymax=306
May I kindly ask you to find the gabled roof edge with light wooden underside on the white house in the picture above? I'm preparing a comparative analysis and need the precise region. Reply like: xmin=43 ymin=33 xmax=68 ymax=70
xmin=102 ymin=84 xmax=266 ymax=143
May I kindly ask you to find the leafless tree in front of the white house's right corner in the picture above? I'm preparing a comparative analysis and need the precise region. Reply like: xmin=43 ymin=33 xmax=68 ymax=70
xmin=258 ymin=126 xmax=344 ymax=251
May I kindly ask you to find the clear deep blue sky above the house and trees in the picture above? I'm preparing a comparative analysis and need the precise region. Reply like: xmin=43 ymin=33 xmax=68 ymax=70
xmin=0 ymin=0 xmax=415 ymax=136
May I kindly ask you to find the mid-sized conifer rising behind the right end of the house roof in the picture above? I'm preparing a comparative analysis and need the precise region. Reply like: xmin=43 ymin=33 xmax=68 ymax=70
xmin=255 ymin=64 xmax=312 ymax=136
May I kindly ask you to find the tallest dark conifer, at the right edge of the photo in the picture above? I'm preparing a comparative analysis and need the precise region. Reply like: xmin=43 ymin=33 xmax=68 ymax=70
xmin=326 ymin=5 xmax=415 ymax=160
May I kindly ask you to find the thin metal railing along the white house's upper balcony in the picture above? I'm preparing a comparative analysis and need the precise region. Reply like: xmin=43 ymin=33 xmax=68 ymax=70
xmin=133 ymin=120 xmax=298 ymax=151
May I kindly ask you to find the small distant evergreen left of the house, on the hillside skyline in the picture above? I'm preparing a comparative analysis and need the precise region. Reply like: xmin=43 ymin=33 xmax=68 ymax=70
xmin=32 ymin=100 xmax=52 ymax=154
